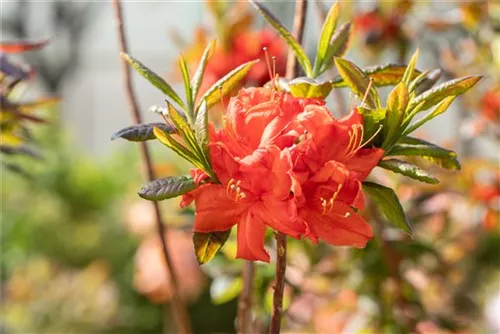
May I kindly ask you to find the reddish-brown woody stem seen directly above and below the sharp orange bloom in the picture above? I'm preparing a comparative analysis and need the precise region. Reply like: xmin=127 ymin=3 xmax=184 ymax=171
xmin=269 ymin=0 xmax=307 ymax=334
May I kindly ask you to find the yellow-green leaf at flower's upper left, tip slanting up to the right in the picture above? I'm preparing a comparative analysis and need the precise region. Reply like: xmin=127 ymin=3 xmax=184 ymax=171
xmin=198 ymin=59 xmax=259 ymax=109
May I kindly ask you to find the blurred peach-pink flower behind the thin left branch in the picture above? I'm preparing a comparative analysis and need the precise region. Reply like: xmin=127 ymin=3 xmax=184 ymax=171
xmin=134 ymin=229 xmax=205 ymax=303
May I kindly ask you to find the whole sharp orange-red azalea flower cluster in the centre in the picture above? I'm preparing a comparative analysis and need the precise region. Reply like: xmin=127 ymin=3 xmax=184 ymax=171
xmin=181 ymin=88 xmax=384 ymax=262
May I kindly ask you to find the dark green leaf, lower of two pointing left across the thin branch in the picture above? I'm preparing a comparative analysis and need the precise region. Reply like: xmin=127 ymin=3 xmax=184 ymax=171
xmin=138 ymin=176 xmax=196 ymax=201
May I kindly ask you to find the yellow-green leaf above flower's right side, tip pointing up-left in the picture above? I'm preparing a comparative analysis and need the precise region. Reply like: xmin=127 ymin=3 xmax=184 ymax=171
xmin=335 ymin=58 xmax=380 ymax=109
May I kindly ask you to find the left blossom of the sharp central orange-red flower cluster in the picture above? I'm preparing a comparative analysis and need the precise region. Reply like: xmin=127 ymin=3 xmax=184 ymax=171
xmin=182 ymin=88 xmax=323 ymax=262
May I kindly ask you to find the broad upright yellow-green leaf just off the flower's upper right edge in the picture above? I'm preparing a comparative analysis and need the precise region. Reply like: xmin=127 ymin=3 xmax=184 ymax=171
xmin=382 ymin=82 xmax=409 ymax=149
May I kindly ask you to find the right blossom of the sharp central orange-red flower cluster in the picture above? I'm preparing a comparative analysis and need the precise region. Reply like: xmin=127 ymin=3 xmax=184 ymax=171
xmin=291 ymin=106 xmax=384 ymax=247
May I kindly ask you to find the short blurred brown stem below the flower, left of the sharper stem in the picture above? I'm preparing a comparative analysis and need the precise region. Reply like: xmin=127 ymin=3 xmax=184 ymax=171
xmin=238 ymin=261 xmax=255 ymax=334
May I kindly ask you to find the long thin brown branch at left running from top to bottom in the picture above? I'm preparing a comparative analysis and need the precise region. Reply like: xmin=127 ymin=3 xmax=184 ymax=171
xmin=112 ymin=0 xmax=191 ymax=334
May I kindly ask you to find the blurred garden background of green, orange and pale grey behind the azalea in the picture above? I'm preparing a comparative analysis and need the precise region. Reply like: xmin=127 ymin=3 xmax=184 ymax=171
xmin=0 ymin=0 xmax=500 ymax=334
